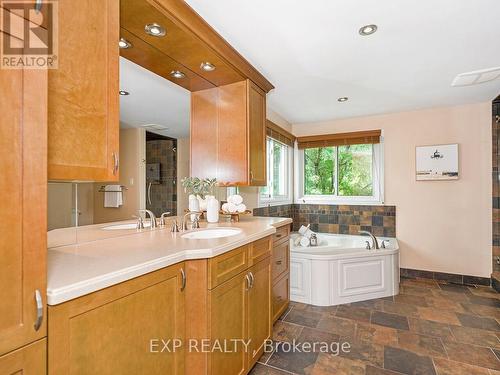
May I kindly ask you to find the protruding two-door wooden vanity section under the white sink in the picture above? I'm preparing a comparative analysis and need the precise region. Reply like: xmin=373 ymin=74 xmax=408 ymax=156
xmin=186 ymin=237 xmax=272 ymax=375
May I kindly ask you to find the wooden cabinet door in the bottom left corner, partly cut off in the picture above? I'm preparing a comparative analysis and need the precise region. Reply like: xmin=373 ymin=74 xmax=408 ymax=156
xmin=0 ymin=339 xmax=47 ymax=375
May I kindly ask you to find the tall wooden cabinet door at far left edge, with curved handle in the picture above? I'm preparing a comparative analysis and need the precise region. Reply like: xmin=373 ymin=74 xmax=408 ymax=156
xmin=0 ymin=10 xmax=47 ymax=356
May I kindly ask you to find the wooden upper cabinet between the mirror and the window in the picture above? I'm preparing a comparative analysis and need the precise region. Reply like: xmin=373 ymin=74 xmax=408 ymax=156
xmin=191 ymin=80 xmax=266 ymax=186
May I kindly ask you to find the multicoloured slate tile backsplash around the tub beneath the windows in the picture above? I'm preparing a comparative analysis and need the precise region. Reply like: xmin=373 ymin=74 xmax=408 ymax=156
xmin=253 ymin=204 xmax=396 ymax=237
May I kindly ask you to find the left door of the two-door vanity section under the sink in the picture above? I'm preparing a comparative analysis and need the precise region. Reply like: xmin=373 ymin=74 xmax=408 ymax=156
xmin=208 ymin=272 xmax=249 ymax=375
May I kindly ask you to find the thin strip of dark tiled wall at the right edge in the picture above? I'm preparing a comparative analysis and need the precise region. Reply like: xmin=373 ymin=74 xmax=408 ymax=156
xmin=491 ymin=96 xmax=500 ymax=272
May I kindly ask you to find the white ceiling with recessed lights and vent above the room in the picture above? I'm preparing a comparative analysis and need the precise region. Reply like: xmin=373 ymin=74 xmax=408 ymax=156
xmin=186 ymin=0 xmax=500 ymax=123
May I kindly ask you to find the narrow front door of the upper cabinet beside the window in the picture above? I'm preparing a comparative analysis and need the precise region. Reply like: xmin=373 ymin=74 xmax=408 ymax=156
xmin=247 ymin=81 xmax=267 ymax=186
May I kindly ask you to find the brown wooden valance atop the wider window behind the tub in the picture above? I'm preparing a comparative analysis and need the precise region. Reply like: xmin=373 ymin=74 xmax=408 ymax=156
xmin=297 ymin=130 xmax=382 ymax=149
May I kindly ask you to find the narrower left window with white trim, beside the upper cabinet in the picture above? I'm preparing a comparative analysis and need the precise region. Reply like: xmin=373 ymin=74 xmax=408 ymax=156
xmin=259 ymin=137 xmax=293 ymax=205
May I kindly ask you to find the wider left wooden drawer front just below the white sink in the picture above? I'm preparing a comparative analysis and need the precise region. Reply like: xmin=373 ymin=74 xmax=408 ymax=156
xmin=208 ymin=244 xmax=248 ymax=289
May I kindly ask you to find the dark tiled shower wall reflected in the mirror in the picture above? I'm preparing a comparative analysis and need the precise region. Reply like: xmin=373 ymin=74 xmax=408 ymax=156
xmin=146 ymin=139 xmax=177 ymax=216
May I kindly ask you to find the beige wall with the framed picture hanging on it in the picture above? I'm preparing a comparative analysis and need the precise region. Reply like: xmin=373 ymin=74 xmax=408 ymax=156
xmin=293 ymin=102 xmax=492 ymax=277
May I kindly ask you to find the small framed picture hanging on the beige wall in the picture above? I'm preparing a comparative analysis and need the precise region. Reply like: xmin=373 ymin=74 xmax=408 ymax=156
xmin=415 ymin=143 xmax=459 ymax=181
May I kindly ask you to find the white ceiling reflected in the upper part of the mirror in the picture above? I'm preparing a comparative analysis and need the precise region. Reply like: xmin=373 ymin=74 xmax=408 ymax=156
xmin=120 ymin=57 xmax=189 ymax=138
